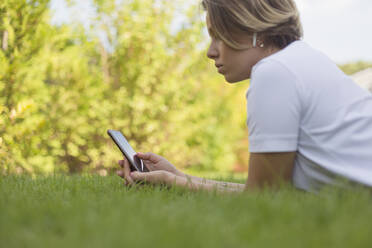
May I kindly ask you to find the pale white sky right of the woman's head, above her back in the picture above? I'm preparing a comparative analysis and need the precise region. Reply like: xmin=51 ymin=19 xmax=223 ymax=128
xmin=296 ymin=0 xmax=372 ymax=63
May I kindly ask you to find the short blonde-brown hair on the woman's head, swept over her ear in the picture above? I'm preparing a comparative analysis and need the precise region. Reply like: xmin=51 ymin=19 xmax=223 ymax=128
xmin=202 ymin=0 xmax=303 ymax=50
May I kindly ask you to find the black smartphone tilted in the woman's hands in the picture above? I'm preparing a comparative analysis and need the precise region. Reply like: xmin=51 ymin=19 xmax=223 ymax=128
xmin=107 ymin=130 xmax=149 ymax=172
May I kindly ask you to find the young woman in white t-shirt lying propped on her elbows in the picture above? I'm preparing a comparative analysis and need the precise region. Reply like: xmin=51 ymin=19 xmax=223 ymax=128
xmin=119 ymin=0 xmax=372 ymax=191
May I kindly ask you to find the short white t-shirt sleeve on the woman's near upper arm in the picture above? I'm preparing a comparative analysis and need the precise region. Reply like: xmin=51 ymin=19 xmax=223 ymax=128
xmin=246 ymin=61 xmax=301 ymax=153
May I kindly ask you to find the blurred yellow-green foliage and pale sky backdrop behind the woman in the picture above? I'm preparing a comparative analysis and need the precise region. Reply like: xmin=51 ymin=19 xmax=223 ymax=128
xmin=0 ymin=0 xmax=372 ymax=175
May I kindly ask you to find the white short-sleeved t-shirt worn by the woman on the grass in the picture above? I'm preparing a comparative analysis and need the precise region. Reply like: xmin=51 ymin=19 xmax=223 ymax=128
xmin=246 ymin=41 xmax=372 ymax=191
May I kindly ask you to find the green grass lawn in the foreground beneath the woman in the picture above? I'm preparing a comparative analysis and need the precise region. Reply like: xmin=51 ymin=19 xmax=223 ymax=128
xmin=0 ymin=176 xmax=372 ymax=248
